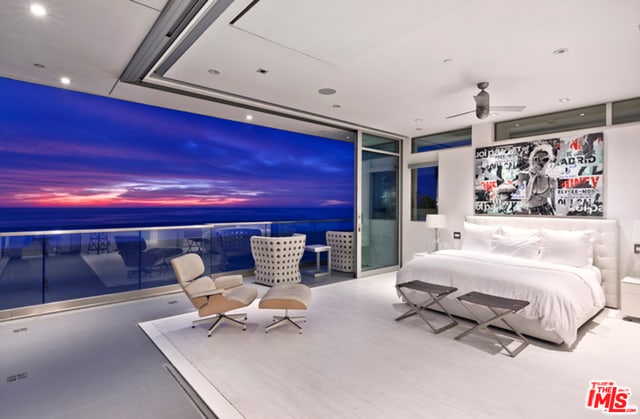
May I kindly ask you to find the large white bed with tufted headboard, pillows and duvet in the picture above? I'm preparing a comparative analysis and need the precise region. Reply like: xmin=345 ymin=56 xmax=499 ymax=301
xmin=396 ymin=216 xmax=619 ymax=346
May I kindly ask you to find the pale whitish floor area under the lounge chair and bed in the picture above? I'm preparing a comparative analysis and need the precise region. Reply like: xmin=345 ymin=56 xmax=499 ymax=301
xmin=141 ymin=274 xmax=640 ymax=419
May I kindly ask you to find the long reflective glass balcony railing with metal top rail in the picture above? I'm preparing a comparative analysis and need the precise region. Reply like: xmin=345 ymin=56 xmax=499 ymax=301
xmin=0 ymin=220 xmax=353 ymax=310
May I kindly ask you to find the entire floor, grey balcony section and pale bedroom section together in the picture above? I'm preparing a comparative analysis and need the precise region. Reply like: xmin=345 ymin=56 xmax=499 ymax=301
xmin=5 ymin=274 xmax=640 ymax=419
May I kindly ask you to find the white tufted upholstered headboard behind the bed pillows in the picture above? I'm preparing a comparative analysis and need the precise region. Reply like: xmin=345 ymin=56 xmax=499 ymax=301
xmin=463 ymin=215 xmax=620 ymax=308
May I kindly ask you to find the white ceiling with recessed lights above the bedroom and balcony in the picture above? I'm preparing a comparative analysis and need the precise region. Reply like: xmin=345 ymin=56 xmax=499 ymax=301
xmin=0 ymin=0 xmax=640 ymax=136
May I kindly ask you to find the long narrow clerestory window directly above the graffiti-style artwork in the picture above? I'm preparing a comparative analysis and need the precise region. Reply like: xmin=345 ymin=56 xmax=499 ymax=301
xmin=495 ymin=104 xmax=607 ymax=141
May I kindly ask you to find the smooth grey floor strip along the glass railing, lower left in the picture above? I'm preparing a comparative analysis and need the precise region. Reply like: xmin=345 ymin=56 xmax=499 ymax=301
xmin=0 ymin=294 xmax=214 ymax=419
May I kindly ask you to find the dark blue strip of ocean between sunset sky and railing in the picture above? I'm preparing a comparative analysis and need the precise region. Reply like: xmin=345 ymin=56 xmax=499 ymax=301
xmin=0 ymin=206 xmax=353 ymax=233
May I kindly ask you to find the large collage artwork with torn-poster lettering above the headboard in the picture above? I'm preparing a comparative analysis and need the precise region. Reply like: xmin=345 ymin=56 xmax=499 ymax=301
xmin=475 ymin=133 xmax=604 ymax=217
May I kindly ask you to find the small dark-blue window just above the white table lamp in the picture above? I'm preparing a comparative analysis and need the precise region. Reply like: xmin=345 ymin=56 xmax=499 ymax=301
xmin=409 ymin=162 xmax=438 ymax=221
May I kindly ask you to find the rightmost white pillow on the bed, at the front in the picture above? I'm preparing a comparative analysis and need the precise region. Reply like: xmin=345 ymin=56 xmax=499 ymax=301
xmin=540 ymin=229 xmax=593 ymax=267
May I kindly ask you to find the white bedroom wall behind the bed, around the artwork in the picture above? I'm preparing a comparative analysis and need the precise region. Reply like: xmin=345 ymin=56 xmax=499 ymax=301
xmin=402 ymin=123 xmax=640 ymax=286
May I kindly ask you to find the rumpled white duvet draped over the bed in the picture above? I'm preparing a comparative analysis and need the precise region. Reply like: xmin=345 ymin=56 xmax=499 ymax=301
xmin=396 ymin=250 xmax=605 ymax=345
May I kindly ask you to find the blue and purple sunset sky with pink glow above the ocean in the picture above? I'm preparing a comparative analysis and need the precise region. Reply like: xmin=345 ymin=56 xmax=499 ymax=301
xmin=0 ymin=78 xmax=353 ymax=207
